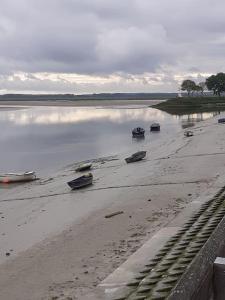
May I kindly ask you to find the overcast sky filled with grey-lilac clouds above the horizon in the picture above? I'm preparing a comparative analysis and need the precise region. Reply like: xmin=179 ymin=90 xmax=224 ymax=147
xmin=0 ymin=0 xmax=225 ymax=94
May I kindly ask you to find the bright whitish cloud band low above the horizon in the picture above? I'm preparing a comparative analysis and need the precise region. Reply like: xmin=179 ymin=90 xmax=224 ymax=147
xmin=0 ymin=73 xmax=179 ymax=94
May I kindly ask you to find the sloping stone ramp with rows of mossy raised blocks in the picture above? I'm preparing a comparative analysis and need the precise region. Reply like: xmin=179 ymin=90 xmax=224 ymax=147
xmin=84 ymin=182 xmax=225 ymax=300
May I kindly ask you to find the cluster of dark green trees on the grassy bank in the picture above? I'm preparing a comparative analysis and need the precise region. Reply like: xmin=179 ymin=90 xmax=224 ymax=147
xmin=181 ymin=72 xmax=225 ymax=96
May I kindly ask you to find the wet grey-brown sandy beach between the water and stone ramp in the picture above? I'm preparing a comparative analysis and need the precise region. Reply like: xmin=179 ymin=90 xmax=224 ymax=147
xmin=0 ymin=111 xmax=225 ymax=300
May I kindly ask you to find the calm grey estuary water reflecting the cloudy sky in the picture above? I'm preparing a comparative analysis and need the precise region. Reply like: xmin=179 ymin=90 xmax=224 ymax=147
xmin=0 ymin=106 xmax=219 ymax=173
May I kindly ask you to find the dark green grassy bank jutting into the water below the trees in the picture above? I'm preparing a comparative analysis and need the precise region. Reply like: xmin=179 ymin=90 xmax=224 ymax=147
xmin=153 ymin=97 xmax=225 ymax=115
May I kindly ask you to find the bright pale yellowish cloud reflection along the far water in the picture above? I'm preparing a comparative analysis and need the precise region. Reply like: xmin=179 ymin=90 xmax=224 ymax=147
xmin=0 ymin=106 xmax=165 ymax=125
